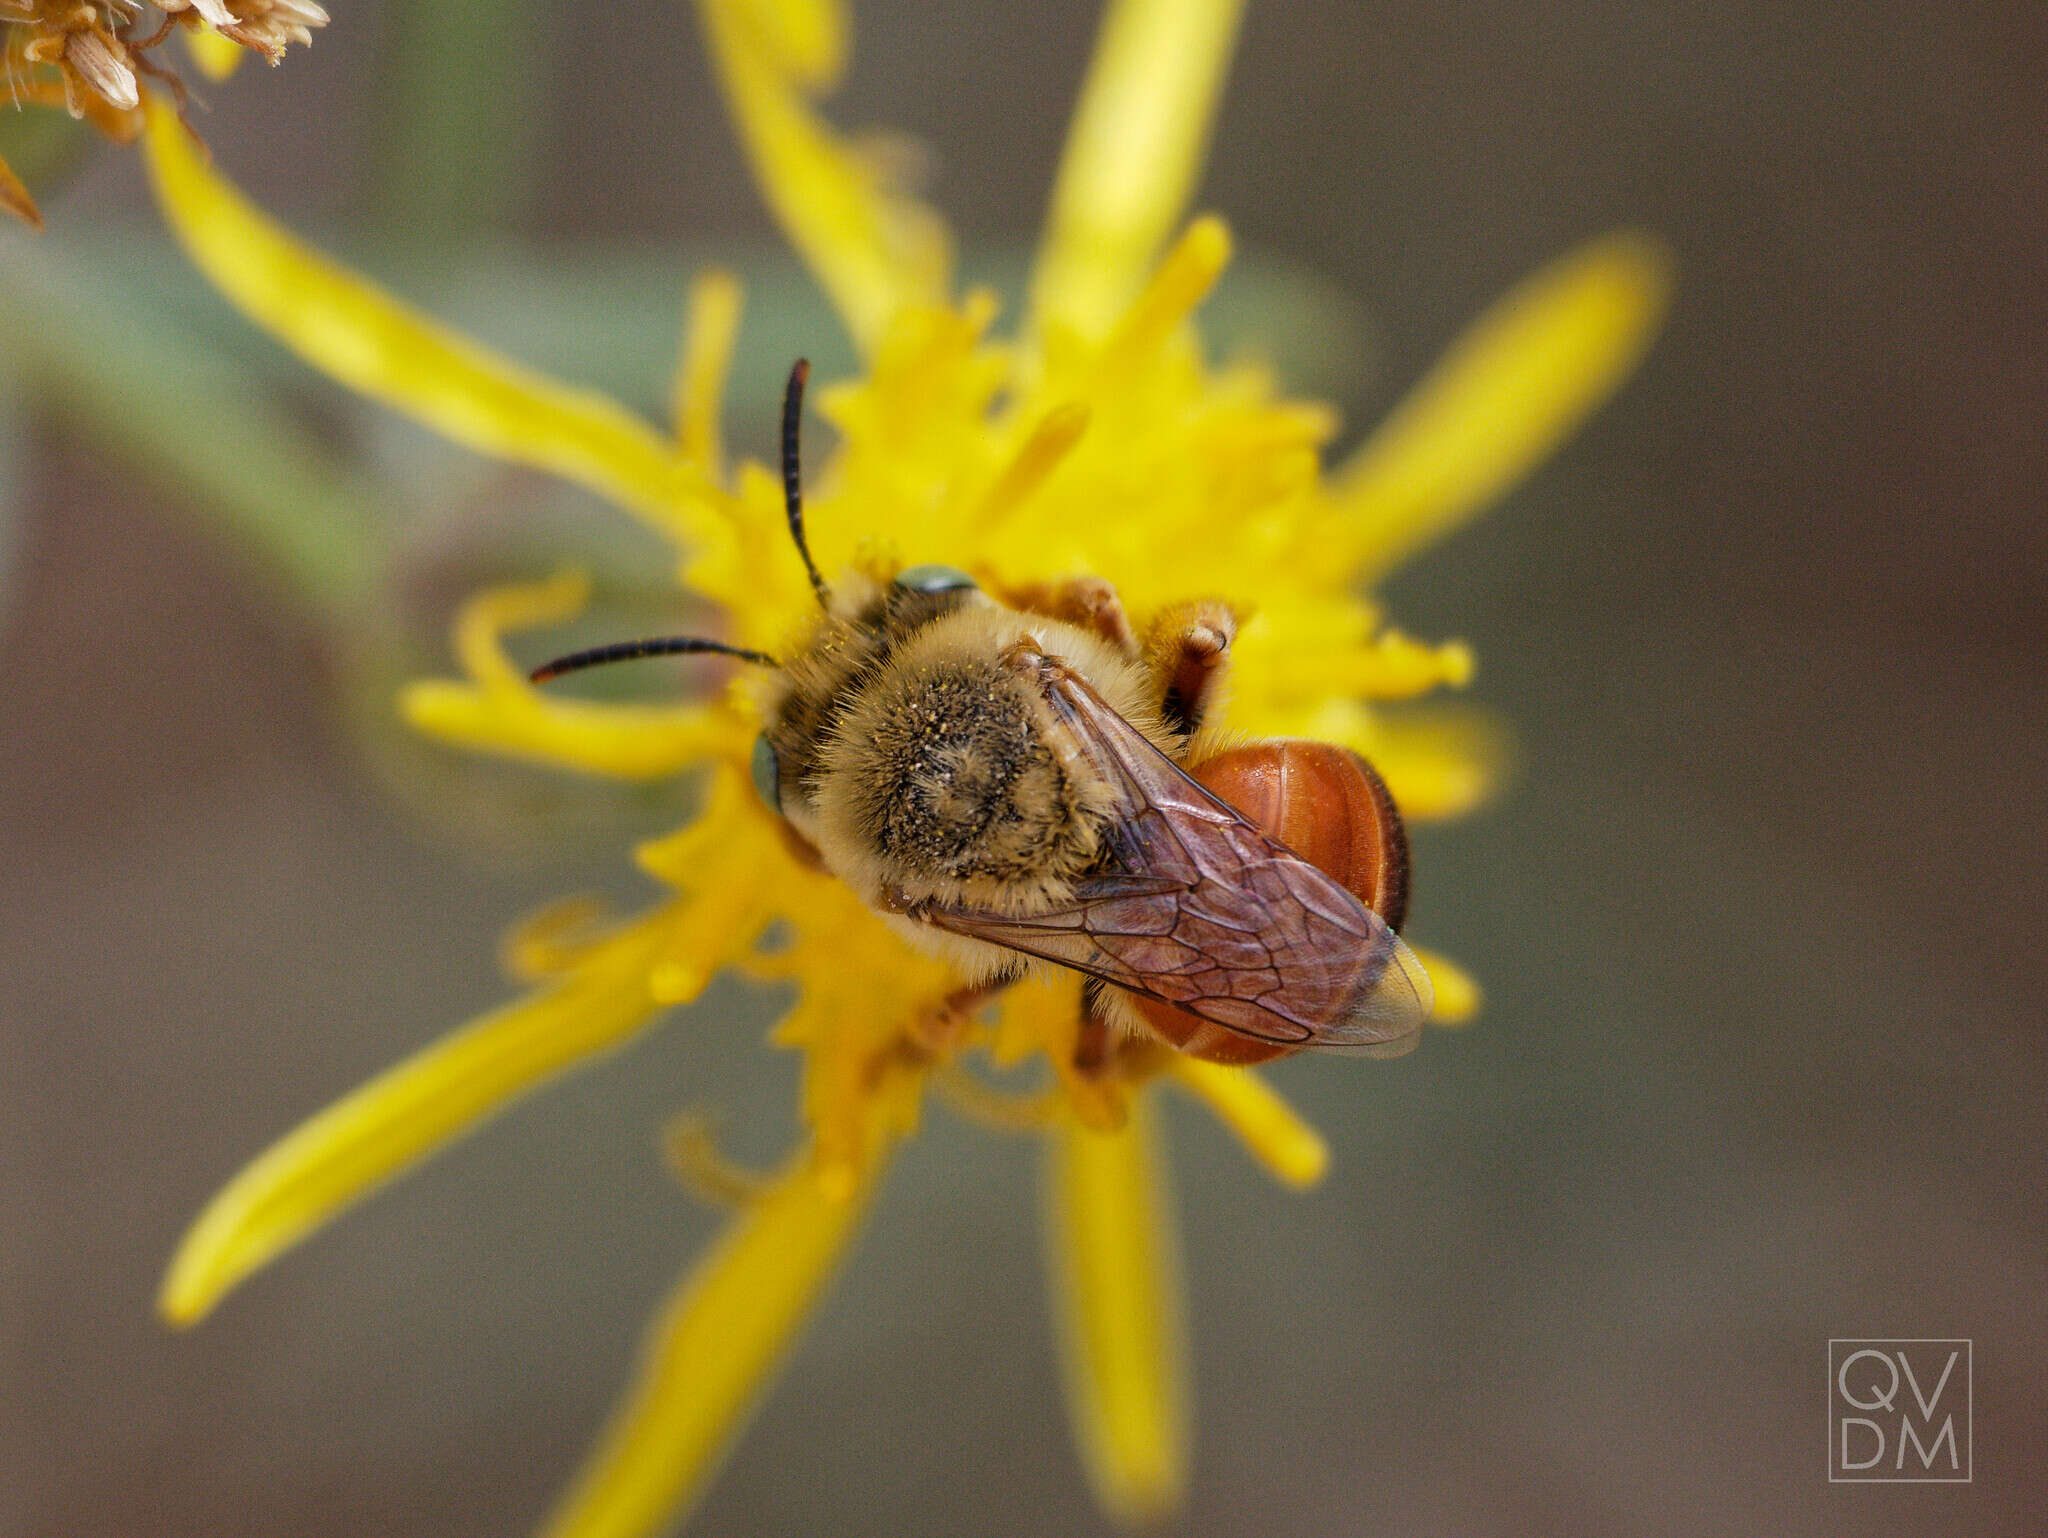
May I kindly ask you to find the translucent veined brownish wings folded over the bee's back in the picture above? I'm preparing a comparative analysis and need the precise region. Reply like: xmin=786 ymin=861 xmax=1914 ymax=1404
xmin=920 ymin=657 xmax=1434 ymax=1055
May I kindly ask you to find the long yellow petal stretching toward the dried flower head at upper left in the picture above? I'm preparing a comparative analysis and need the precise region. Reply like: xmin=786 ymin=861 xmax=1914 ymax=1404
xmin=145 ymin=98 xmax=729 ymax=543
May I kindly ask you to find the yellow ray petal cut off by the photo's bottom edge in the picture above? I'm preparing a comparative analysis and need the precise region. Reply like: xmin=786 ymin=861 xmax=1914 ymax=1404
xmin=541 ymin=1155 xmax=881 ymax=1538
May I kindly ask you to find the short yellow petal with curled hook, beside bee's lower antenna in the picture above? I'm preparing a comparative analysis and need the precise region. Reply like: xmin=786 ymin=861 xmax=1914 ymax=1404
xmin=399 ymin=571 xmax=748 ymax=780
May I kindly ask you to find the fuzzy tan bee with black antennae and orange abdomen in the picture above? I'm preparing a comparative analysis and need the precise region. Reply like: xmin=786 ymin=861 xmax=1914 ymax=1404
xmin=532 ymin=360 xmax=1432 ymax=1071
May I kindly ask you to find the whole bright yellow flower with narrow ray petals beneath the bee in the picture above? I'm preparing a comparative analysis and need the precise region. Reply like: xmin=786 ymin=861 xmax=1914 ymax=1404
xmin=147 ymin=0 xmax=1667 ymax=1538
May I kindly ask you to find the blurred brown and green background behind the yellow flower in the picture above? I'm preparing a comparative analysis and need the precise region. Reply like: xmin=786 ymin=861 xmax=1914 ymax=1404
xmin=0 ymin=0 xmax=2048 ymax=1538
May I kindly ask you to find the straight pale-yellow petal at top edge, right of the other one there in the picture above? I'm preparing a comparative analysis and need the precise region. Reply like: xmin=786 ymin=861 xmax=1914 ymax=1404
xmin=1030 ymin=0 xmax=1243 ymax=338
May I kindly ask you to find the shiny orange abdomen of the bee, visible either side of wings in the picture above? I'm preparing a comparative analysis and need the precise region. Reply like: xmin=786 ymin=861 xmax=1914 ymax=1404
xmin=1133 ymin=739 xmax=1409 ymax=1065
